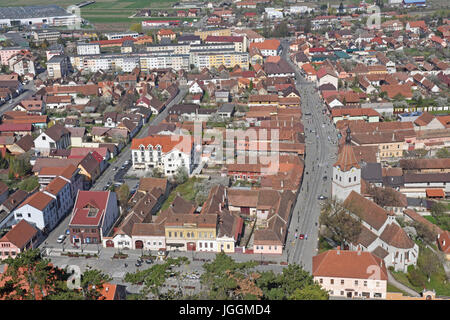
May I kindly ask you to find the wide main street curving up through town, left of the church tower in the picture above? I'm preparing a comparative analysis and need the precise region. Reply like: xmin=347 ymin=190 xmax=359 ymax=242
xmin=281 ymin=40 xmax=337 ymax=272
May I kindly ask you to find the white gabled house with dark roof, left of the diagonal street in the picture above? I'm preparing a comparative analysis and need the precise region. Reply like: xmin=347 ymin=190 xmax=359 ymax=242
xmin=34 ymin=124 xmax=70 ymax=156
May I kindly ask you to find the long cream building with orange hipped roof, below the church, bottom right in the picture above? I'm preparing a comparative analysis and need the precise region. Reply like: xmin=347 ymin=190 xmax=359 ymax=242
xmin=312 ymin=248 xmax=388 ymax=299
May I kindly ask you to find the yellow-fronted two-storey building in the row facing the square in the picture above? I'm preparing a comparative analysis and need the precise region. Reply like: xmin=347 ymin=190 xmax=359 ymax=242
xmin=165 ymin=214 xmax=218 ymax=252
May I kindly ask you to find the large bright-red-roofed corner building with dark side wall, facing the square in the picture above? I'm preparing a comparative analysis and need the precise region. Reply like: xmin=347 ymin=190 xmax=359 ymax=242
xmin=69 ymin=190 xmax=119 ymax=245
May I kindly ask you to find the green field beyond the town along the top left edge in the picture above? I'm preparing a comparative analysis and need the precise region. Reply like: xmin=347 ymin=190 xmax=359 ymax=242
xmin=0 ymin=0 xmax=179 ymax=31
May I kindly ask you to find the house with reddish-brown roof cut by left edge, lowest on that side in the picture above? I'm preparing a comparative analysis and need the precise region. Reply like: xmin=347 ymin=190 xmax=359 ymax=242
xmin=0 ymin=220 xmax=40 ymax=260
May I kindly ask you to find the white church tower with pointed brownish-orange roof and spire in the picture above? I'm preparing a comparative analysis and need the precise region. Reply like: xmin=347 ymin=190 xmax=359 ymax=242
xmin=331 ymin=127 xmax=361 ymax=201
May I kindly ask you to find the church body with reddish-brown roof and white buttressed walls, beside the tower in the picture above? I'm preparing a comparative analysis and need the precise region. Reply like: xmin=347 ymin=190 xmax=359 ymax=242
xmin=343 ymin=191 xmax=419 ymax=272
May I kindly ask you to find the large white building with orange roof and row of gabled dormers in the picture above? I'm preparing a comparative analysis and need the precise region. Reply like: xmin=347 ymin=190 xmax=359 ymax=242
xmin=131 ymin=135 xmax=195 ymax=175
